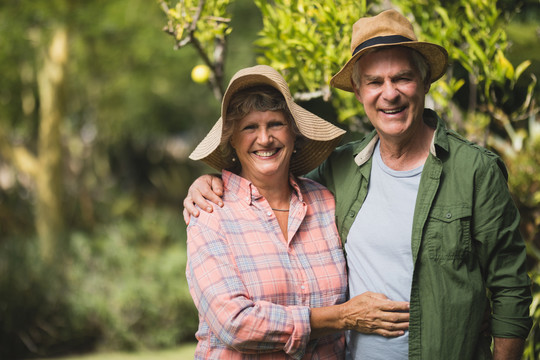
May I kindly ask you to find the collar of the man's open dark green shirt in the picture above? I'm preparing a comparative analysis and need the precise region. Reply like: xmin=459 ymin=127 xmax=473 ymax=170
xmin=354 ymin=109 xmax=448 ymax=166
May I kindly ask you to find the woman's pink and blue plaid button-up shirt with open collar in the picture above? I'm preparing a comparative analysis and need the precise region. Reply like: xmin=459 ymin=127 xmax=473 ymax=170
xmin=186 ymin=171 xmax=347 ymax=359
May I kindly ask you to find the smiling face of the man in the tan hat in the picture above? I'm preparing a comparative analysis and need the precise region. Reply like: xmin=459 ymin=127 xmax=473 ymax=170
xmin=354 ymin=47 xmax=429 ymax=141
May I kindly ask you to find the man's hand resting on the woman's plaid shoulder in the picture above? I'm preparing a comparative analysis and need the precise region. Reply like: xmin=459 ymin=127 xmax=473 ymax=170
xmin=183 ymin=175 xmax=223 ymax=225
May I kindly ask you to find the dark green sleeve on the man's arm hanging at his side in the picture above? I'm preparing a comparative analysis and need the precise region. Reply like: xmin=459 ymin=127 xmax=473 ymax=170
xmin=473 ymin=157 xmax=532 ymax=339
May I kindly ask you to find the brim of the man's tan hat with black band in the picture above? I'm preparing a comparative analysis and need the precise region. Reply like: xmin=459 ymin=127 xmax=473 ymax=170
xmin=330 ymin=41 xmax=448 ymax=92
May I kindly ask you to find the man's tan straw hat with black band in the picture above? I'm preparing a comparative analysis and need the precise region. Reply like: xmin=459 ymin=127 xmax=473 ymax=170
xmin=330 ymin=10 xmax=448 ymax=92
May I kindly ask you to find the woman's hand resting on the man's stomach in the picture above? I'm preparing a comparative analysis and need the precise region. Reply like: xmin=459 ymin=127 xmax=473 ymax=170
xmin=341 ymin=292 xmax=409 ymax=337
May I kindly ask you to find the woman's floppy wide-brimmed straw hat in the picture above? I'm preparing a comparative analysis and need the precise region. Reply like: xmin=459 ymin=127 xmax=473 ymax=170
xmin=189 ymin=65 xmax=345 ymax=175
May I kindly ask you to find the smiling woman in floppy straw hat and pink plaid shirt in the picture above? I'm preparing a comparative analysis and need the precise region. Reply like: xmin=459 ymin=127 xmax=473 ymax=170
xmin=186 ymin=65 xmax=356 ymax=359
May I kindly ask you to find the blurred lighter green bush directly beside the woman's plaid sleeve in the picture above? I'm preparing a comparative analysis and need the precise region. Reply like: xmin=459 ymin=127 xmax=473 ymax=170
xmin=68 ymin=208 xmax=198 ymax=349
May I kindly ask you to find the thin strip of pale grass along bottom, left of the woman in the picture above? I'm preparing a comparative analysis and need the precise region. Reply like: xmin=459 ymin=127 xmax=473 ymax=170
xmin=38 ymin=344 xmax=195 ymax=360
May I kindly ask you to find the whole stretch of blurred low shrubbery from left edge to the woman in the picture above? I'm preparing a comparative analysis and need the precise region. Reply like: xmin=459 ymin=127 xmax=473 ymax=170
xmin=0 ymin=207 xmax=198 ymax=358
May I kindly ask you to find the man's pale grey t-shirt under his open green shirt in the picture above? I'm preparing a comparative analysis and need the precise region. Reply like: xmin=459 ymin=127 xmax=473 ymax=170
xmin=345 ymin=143 xmax=423 ymax=360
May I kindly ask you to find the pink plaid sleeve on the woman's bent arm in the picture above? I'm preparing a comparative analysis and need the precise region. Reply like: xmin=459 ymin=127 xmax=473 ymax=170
xmin=186 ymin=214 xmax=311 ymax=359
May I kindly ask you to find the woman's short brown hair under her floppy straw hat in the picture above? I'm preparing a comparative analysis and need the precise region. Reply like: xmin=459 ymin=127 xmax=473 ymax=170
xmin=220 ymin=85 xmax=302 ymax=171
